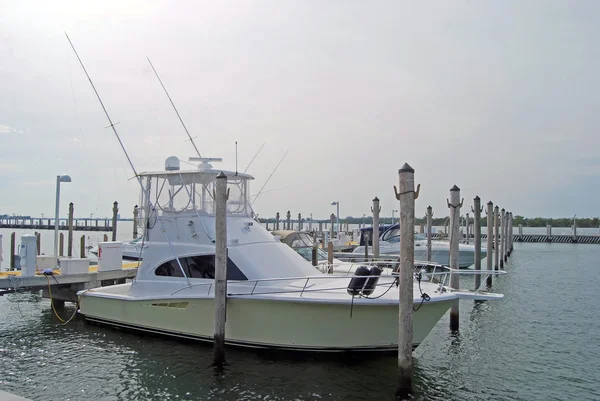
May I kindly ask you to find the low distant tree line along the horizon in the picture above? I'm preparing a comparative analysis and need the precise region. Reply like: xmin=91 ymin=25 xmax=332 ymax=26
xmin=259 ymin=212 xmax=600 ymax=228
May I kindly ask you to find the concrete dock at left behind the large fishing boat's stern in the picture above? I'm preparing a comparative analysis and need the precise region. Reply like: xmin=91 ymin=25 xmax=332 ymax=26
xmin=0 ymin=262 xmax=138 ymax=305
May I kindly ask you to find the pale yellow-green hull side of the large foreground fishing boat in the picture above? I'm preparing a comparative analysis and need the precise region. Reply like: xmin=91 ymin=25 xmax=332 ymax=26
xmin=80 ymin=288 xmax=457 ymax=352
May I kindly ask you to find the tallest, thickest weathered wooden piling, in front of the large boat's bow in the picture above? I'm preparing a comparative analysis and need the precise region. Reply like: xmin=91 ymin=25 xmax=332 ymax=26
xmin=396 ymin=163 xmax=418 ymax=399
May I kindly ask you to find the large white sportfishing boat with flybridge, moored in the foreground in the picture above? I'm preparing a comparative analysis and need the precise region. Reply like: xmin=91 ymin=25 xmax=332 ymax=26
xmin=79 ymin=158 xmax=502 ymax=351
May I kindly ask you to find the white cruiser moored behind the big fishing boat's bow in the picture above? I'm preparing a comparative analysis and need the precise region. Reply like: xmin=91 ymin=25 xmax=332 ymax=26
xmin=353 ymin=224 xmax=487 ymax=269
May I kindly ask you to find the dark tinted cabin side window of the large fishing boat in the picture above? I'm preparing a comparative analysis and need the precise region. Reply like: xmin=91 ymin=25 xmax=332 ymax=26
xmin=154 ymin=255 xmax=248 ymax=280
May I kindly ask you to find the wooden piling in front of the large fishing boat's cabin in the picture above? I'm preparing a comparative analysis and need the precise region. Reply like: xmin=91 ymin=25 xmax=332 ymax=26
xmin=213 ymin=171 xmax=227 ymax=365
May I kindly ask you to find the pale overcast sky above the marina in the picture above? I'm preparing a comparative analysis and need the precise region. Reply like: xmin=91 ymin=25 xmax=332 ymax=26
xmin=0 ymin=0 xmax=600 ymax=218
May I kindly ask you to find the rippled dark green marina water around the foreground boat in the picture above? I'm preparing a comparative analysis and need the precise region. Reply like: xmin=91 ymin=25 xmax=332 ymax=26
xmin=0 ymin=244 xmax=600 ymax=400
